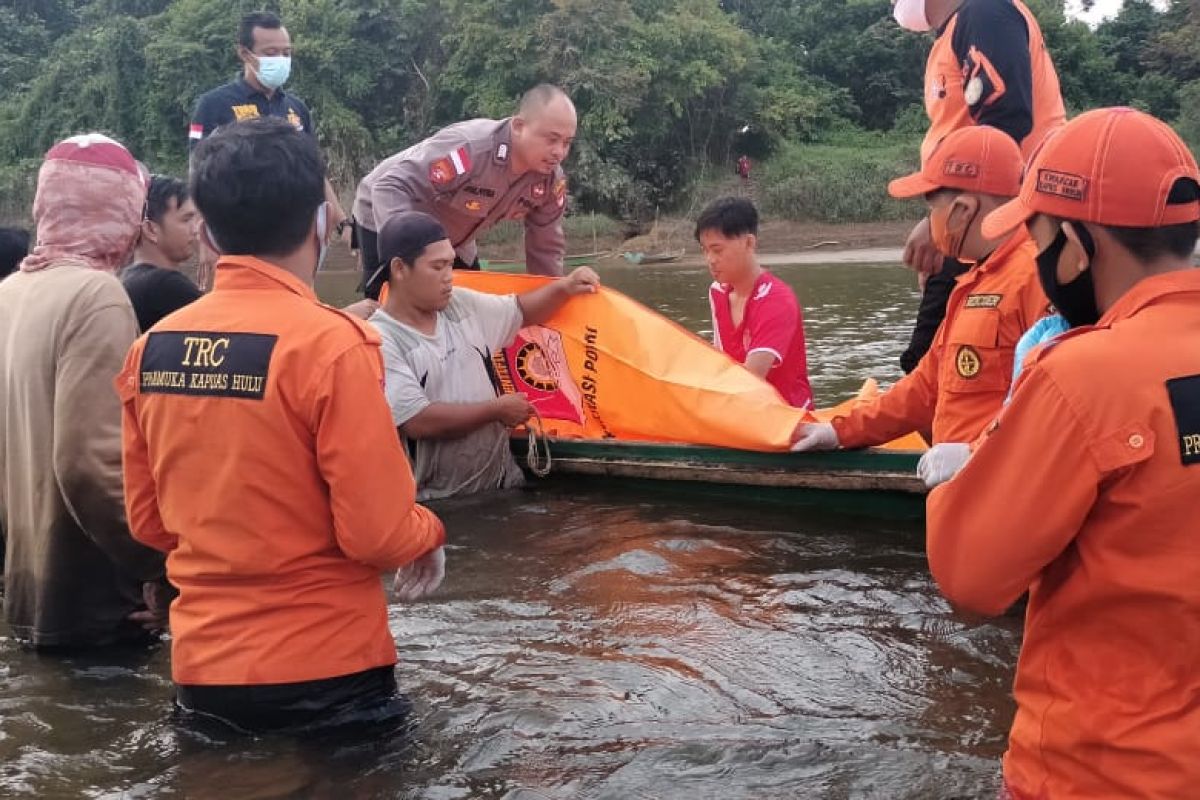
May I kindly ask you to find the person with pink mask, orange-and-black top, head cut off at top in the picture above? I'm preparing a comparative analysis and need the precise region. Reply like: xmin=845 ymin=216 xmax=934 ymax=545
xmin=892 ymin=0 xmax=1067 ymax=372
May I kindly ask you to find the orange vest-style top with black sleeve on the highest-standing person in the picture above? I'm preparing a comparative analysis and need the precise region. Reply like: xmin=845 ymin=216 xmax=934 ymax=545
xmin=920 ymin=0 xmax=1067 ymax=162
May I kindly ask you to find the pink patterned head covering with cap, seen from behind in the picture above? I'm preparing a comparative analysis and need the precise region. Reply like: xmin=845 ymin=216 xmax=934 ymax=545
xmin=20 ymin=133 xmax=146 ymax=272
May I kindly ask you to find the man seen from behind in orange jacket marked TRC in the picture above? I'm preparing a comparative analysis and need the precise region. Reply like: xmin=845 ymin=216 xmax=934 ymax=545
xmin=118 ymin=119 xmax=444 ymax=730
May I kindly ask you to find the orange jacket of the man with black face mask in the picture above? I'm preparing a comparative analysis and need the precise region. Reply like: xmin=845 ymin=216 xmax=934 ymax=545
xmin=928 ymin=270 xmax=1200 ymax=800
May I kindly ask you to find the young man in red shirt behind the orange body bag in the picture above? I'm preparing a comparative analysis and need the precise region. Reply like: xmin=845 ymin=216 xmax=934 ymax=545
xmin=696 ymin=197 xmax=812 ymax=408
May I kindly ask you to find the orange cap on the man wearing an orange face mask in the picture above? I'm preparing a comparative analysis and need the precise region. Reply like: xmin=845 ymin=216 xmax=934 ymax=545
xmin=888 ymin=125 xmax=1025 ymax=197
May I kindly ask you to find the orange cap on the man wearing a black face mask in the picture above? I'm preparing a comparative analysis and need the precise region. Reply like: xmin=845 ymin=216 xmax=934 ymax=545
xmin=983 ymin=108 xmax=1200 ymax=239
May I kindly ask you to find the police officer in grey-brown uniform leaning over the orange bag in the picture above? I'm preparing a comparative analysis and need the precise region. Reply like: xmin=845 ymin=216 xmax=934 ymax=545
xmin=354 ymin=84 xmax=577 ymax=297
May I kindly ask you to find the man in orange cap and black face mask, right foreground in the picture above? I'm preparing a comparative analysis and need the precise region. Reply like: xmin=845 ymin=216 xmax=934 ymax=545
xmin=928 ymin=109 xmax=1200 ymax=800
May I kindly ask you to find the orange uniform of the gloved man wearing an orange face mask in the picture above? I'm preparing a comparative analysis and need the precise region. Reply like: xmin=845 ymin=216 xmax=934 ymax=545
xmin=830 ymin=227 xmax=1049 ymax=447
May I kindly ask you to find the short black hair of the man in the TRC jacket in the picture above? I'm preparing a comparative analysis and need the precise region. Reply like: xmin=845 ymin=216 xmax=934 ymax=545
xmin=191 ymin=118 xmax=325 ymax=255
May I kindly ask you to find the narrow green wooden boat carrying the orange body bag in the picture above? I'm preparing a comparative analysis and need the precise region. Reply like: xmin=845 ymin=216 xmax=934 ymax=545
xmin=512 ymin=437 xmax=925 ymax=519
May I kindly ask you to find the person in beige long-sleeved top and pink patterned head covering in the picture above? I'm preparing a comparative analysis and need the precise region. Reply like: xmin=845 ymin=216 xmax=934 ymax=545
xmin=0 ymin=133 xmax=169 ymax=649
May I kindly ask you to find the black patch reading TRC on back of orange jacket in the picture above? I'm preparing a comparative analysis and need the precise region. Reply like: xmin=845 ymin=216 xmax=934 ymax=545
xmin=139 ymin=331 xmax=278 ymax=399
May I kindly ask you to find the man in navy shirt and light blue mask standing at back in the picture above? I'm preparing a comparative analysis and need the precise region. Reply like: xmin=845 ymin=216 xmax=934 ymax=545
xmin=187 ymin=11 xmax=349 ymax=240
